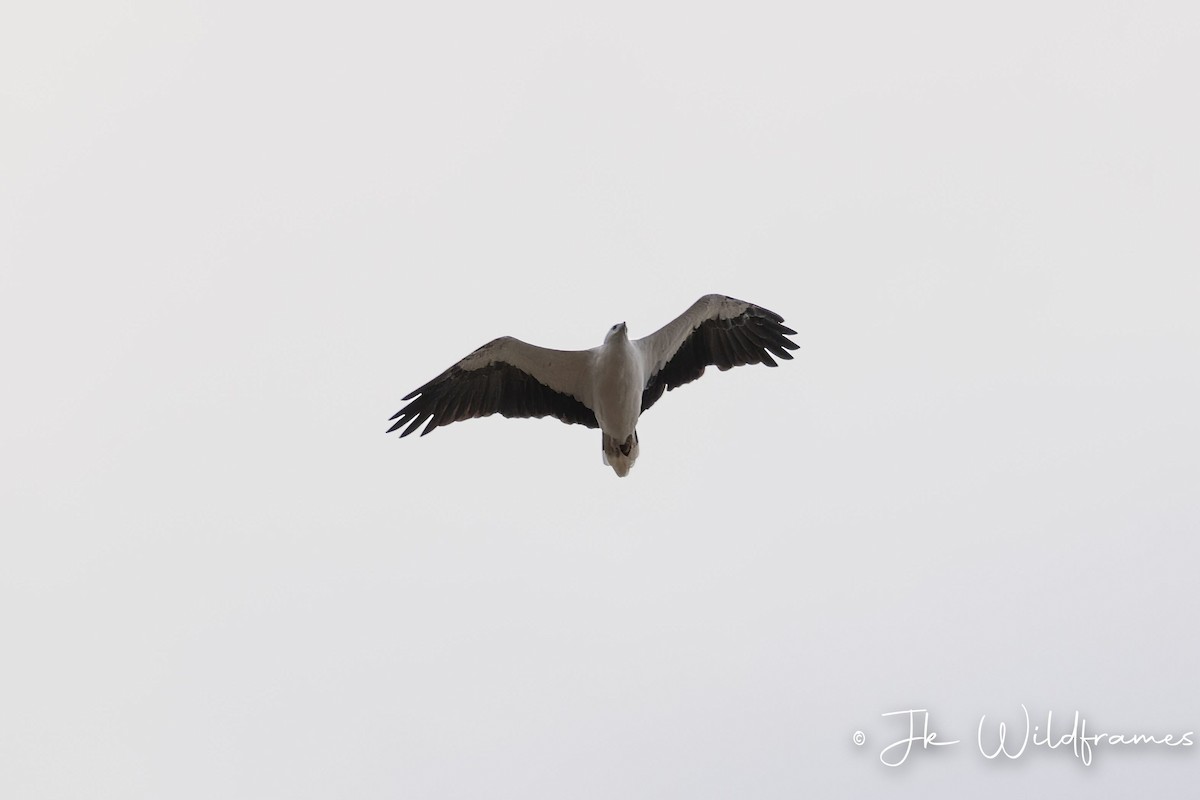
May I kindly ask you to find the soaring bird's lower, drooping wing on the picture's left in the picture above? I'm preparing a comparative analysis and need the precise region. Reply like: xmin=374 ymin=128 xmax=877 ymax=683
xmin=388 ymin=336 xmax=600 ymax=437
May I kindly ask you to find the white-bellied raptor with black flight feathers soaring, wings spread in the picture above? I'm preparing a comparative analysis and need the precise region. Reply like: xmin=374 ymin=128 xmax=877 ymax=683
xmin=388 ymin=294 xmax=799 ymax=477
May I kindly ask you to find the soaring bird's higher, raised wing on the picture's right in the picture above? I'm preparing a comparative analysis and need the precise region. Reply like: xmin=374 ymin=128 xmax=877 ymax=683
xmin=636 ymin=294 xmax=799 ymax=411
